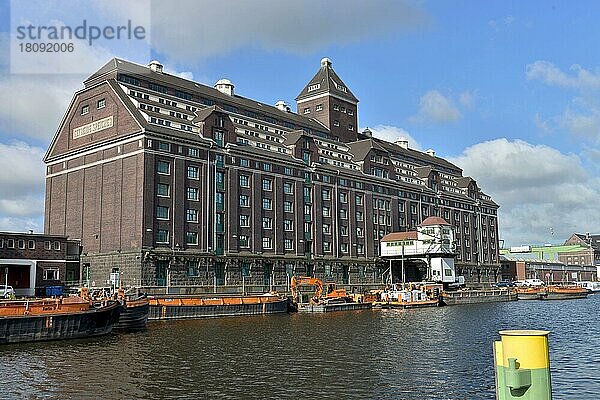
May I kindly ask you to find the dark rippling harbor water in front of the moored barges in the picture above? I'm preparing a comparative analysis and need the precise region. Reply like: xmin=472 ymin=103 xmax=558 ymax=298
xmin=0 ymin=294 xmax=600 ymax=400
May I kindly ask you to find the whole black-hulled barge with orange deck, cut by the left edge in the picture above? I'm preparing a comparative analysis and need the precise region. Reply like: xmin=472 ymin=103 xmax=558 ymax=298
xmin=0 ymin=297 xmax=119 ymax=344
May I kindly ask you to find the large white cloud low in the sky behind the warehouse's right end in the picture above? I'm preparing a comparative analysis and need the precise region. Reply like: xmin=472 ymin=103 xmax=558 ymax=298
xmin=449 ymin=139 xmax=600 ymax=245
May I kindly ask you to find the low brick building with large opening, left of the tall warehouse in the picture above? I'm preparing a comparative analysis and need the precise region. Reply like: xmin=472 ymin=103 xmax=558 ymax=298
xmin=0 ymin=232 xmax=80 ymax=296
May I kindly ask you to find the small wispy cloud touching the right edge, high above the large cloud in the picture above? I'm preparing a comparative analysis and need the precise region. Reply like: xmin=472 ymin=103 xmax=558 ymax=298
xmin=525 ymin=60 xmax=600 ymax=89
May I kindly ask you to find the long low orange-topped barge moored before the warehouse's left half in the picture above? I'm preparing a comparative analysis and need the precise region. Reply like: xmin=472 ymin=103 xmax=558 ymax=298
xmin=148 ymin=294 xmax=288 ymax=320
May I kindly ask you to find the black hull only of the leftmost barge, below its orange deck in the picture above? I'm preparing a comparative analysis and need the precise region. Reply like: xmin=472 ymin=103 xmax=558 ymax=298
xmin=0 ymin=301 xmax=119 ymax=344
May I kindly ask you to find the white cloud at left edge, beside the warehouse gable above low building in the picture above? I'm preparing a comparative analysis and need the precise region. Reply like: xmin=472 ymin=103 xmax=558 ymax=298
xmin=0 ymin=142 xmax=45 ymax=231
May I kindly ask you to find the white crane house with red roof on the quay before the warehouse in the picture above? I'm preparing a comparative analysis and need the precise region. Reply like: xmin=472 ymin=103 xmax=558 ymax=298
xmin=381 ymin=217 xmax=456 ymax=283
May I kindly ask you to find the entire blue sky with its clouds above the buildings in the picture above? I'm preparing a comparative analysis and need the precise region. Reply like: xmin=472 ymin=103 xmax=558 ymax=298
xmin=0 ymin=0 xmax=600 ymax=246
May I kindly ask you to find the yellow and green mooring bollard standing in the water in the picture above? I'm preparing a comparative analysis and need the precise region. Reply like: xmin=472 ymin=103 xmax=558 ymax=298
xmin=494 ymin=330 xmax=552 ymax=400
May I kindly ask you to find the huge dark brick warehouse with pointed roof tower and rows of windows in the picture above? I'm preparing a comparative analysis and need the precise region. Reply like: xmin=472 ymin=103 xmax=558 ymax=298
xmin=45 ymin=59 xmax=499 ymax=291
